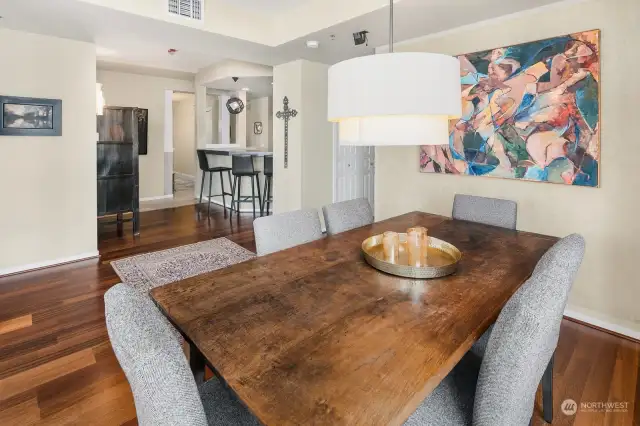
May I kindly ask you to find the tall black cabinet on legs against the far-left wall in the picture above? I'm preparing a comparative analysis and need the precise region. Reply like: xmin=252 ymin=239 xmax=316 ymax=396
xmin=97 ymin=107 xmax=140 ymax=235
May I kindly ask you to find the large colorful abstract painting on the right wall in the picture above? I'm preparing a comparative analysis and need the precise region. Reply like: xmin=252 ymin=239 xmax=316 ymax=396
xmin=420 ymin=30 xmax=600 ymax=187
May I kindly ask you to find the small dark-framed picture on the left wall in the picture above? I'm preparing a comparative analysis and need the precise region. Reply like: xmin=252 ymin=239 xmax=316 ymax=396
xmin=0 ymin=96 xmax=62 ymax=136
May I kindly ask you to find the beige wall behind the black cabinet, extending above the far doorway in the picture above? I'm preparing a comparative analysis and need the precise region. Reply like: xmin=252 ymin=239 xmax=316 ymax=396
xmin=98 ymin=70 xmax=194 ymax=198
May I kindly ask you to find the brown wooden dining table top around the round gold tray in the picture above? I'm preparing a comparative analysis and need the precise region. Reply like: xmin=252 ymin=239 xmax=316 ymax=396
xmin=150 ymin=212 xmax=557 ymax=426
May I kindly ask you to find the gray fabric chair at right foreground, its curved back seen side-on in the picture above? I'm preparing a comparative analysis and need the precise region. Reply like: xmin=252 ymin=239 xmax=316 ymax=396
xmin=405 ymin=234 xmax=585 ymax=426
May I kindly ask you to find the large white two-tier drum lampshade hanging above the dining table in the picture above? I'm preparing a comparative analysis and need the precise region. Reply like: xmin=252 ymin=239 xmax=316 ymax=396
xmin=328 ymin=52 xmax=462 ymax=146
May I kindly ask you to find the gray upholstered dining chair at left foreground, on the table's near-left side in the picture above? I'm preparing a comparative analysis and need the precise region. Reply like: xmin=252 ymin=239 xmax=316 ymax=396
xmin=104 ymin=284 xmax=260 ymax=426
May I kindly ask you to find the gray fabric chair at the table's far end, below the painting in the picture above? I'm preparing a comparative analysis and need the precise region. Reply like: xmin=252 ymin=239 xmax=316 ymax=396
xmin=452 ymin=194 xmax=518 ymax=229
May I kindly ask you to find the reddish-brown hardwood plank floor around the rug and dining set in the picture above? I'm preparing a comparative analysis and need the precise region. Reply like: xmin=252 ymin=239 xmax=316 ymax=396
xmin=0 ymin=206 xmax=640 ymax=426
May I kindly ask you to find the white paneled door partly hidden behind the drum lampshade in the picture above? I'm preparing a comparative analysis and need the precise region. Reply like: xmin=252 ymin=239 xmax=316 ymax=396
xmin=333 ymin=125 xmax=376 ymax=207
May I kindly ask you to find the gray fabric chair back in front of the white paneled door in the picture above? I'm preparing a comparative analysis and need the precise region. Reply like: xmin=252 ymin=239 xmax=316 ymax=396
xmin=322 ymin=198 xmax=373 ymax=235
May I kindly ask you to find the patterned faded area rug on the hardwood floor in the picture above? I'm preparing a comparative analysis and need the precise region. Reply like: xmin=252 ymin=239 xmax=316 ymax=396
xmin=111 ymin=238 xmax=256 ymax=294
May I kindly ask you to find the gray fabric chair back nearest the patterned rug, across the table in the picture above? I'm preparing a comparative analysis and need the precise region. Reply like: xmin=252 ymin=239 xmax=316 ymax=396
xmin=253 ymin=209 xmax=322 ymax=256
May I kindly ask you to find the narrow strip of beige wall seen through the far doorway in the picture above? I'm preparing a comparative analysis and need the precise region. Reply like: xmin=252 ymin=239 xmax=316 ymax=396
xmin=173 ymin=95 xmax=197 ymax=177
